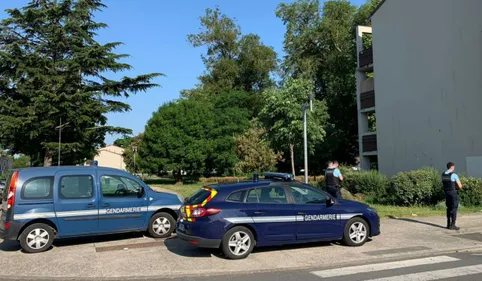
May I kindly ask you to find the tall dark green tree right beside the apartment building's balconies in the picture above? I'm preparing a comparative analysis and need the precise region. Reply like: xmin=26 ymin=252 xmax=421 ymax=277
xmin=276 ymin=0 xmax=379 ymax=165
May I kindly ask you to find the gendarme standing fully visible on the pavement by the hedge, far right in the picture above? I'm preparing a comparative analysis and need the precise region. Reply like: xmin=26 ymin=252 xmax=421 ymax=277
xmin=442 ymin=162 xmax=462 ymax=230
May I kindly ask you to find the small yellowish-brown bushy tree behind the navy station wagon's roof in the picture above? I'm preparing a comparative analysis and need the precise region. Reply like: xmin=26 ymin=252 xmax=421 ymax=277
xmin=235 ymin=121 xmax=281 ymax=173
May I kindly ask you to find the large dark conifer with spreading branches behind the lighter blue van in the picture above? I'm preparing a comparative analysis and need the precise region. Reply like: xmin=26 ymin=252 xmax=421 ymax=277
xmin=0 ymin=0 xmax=161 ymax=166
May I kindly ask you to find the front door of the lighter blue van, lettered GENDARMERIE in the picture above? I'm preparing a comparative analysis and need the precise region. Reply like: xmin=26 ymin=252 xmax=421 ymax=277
xmin=99 ymin=172 xmax=147 ymax=233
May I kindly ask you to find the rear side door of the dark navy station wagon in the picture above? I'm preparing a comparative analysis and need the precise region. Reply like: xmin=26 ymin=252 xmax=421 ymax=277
xmin=247 ymin=185 xmax=296 ymax=241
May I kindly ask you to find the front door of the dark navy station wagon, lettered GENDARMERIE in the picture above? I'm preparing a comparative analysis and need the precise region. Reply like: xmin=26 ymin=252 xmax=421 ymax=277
xmin=289 ymin=183 xmax=343 ymax=240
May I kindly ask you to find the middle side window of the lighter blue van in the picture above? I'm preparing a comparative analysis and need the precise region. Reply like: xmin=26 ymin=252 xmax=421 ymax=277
xmin=60 ymin=175 xmax=94 ymax=199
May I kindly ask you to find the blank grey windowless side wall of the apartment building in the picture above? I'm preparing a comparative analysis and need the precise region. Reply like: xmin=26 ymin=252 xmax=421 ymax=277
xmin=372 ymin=0 xmax=482 ymax=176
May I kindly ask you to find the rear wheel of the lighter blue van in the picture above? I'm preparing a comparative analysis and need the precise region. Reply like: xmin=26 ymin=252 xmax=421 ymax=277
xmin=19 ymin=223 xmax=55 ymax=253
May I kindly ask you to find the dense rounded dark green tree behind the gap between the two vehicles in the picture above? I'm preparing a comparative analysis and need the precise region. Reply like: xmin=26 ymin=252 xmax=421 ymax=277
xmin=139 ymin=100 xmax=215 ymax=183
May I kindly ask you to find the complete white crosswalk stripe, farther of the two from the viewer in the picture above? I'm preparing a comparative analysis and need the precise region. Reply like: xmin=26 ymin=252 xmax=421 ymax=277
xmin=311 ymin=256 xmax=459 ymax=276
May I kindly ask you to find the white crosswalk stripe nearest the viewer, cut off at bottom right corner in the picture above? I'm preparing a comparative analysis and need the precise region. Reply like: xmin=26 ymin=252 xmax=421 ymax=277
xmin=366 ymin=264 xmax=482 ymax=281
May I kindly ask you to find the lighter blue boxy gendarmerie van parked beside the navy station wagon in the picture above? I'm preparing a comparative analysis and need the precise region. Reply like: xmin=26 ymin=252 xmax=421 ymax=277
xmin=0 ymin=166 xmax=184 ymax=253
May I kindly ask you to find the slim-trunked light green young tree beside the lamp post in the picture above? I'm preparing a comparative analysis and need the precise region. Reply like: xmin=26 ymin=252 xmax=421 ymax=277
xmin=259 ymin=78 xmax=328 ymax=174
